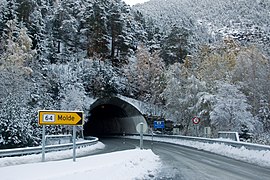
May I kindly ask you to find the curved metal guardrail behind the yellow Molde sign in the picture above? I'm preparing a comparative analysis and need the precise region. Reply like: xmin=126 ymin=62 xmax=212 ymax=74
xmin=0 ymin=137 xmax=98 ymax=157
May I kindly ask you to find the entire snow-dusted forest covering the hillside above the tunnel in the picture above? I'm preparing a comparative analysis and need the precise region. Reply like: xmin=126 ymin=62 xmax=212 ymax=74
xmin=0 ymin=0 xmax=270 ymax=148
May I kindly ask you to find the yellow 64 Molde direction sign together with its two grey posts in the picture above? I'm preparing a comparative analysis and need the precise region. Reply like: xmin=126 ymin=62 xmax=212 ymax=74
xmin=38 ymin=110 xmax=83 ymax=162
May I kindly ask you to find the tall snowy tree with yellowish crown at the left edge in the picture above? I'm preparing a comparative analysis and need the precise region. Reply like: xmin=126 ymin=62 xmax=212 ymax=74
xmin=0 ymin=20 xmax=39 ymax=148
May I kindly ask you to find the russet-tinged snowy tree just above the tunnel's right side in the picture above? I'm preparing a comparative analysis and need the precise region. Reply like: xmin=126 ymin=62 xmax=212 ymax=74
xmin=126 ymin=46 xmax=166 ymax=104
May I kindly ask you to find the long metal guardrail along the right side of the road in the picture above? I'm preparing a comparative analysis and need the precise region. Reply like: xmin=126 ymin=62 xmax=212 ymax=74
xmin=141 ymin=134 xmax=270 ymax=151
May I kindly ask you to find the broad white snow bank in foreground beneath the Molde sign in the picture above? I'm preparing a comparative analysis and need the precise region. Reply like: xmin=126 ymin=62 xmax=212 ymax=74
xmin=0 ymin=143 xmax=161 ymax=180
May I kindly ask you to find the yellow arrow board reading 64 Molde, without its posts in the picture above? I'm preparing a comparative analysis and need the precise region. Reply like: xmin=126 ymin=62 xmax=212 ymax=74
xmin=38 ymin=110 xmax=83 ymax=126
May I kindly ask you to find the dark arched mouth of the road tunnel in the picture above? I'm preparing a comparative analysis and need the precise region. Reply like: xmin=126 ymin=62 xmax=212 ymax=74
xmin=83 ymin=97 xmax=147 ymax=137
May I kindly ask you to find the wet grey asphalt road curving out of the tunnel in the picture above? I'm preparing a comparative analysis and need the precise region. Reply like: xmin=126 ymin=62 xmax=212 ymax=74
xmin=101 ymin=139 xmax=270 ymax=180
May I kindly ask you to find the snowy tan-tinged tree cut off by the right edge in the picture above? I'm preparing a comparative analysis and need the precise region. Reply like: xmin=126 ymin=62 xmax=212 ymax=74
xmin=232 ymin=47 xmax=270 ymax=114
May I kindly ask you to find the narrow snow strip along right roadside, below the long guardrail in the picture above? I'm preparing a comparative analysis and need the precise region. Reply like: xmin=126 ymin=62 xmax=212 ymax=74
xmin=127 ymin=136 xmax=270 ymax=168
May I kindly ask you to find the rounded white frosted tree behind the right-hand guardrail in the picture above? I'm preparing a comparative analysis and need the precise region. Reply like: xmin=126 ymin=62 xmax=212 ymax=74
xmin=210 ymin=81 xmax=259 ymax=132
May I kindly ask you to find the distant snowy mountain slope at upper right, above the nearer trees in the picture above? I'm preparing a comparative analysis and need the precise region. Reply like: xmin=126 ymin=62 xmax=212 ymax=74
xmin=134 ymin=0 xmax=270 ymax=53
